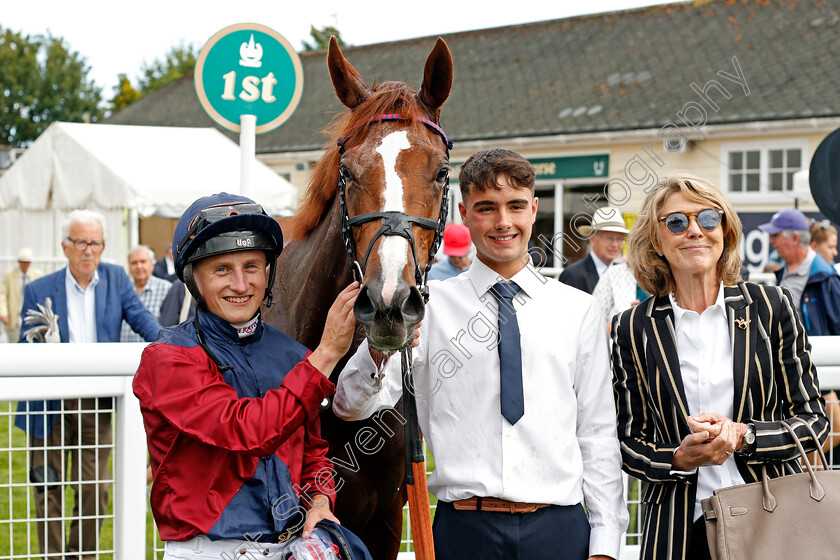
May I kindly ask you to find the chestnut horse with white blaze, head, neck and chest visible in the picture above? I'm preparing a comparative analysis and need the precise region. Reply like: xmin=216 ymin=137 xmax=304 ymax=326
xmin=265 ymin=38 xmax=452 ymax=560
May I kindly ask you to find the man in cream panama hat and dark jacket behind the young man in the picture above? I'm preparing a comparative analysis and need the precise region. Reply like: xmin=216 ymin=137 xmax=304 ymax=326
xmin=560 ymin=207 xmax=630 ymax=294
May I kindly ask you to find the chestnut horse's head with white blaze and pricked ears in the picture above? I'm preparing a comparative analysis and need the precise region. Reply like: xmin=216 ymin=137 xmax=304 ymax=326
xmin=328 ymin=39 xmax=452 ymax=350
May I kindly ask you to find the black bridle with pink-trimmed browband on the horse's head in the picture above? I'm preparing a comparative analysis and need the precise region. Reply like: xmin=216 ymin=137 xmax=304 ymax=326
xmin=337 ymin=113 xmax=452 ymax=303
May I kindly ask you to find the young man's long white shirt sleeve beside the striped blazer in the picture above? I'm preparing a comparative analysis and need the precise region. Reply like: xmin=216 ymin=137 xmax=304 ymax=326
xmin=575 ymin=300 xmax=629 ymax=558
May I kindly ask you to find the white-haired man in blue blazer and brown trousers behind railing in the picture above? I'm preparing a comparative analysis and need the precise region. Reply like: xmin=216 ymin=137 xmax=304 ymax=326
xmin=15 ymin=210 xmax=160 ymax=558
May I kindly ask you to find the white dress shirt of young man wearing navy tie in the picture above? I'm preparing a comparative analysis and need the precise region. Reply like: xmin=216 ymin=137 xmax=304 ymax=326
xmin=333 ymin=260 xmax=628 ymax=558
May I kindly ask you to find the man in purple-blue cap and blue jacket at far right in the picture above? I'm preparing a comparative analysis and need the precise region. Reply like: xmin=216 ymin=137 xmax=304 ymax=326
xmin=758 ymin=208 xmax=840 ymax=336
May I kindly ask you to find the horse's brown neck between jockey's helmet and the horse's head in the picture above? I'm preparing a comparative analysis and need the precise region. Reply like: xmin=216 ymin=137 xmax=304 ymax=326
xmin=268 ymin=197 xmax=352 ymax=349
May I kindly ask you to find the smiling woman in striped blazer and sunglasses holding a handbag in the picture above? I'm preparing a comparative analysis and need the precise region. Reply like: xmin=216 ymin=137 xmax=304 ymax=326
xmin=612 ymin=175 xmax=828 ymax=560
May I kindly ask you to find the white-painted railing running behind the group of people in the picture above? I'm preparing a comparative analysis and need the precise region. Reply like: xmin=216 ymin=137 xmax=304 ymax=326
xmin=0 ymin=337 xmax=840 ymax=560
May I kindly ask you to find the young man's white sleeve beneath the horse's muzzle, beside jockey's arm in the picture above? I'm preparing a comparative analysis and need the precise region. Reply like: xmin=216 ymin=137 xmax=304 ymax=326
xmin=333 ymin=340 xmax=402 ymax=420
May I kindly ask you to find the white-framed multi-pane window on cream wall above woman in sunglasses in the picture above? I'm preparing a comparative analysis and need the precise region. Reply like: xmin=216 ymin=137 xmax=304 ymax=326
xmin=724 ymin=146 xmax=805 ymax=193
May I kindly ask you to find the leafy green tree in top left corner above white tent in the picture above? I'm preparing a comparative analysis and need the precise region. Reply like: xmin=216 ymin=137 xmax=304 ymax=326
xmin=0 ymin=28 xmax=102 ymax=147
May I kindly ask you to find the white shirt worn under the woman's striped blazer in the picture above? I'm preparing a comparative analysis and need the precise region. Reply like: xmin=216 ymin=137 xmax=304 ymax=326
xmin=670 ymin=284 xmax=744 ymax=521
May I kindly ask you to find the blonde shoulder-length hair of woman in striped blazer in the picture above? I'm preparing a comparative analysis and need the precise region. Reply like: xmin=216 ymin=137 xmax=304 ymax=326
xmin=627 ymin=174 xmax=743 ymax=296
